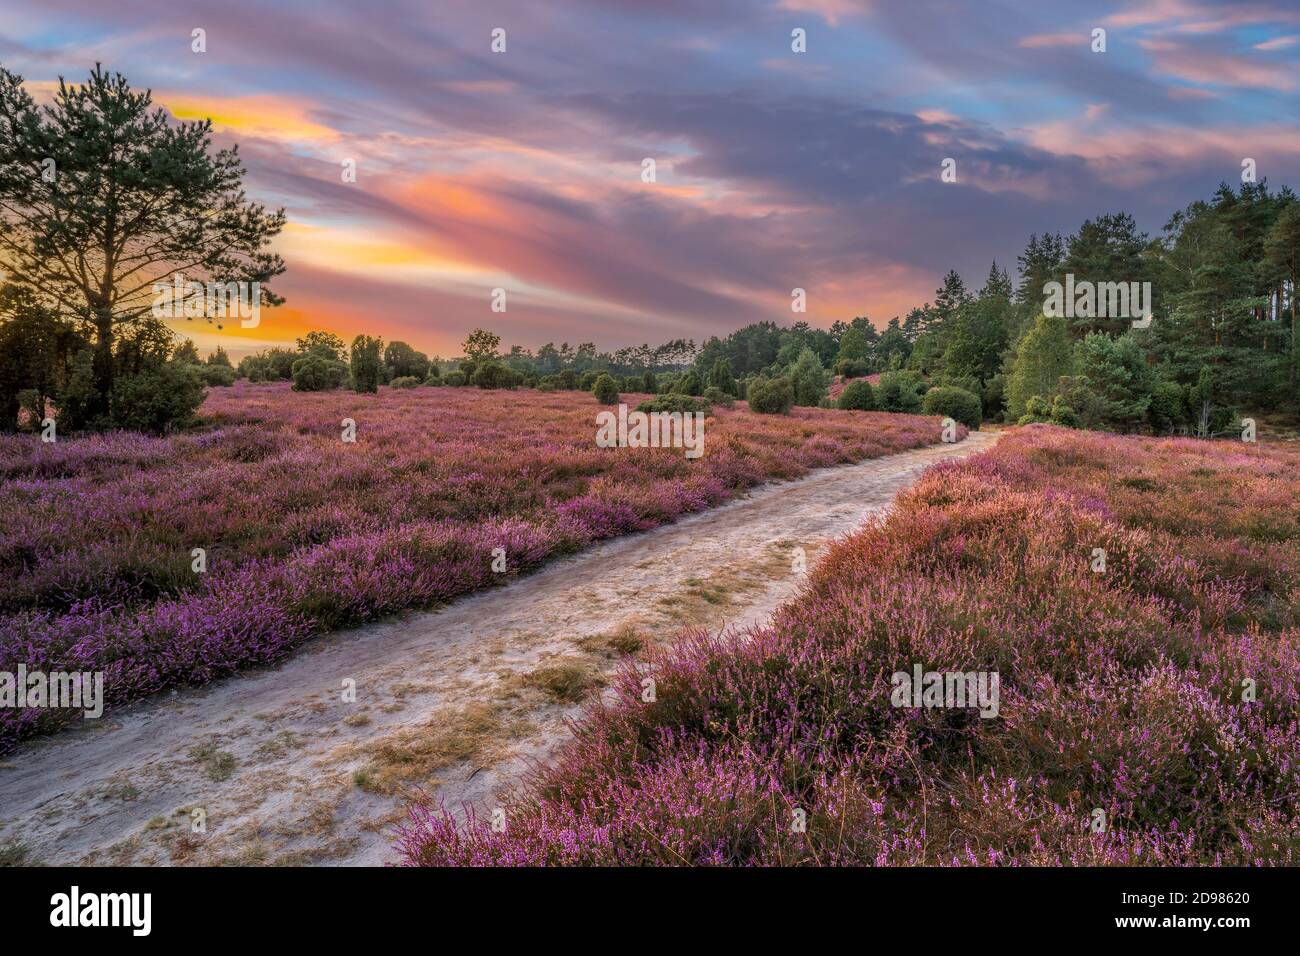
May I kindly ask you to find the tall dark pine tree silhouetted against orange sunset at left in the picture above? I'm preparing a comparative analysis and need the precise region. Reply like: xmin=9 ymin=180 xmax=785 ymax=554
xmin=0 ymin=59 xmax=285 ymax=420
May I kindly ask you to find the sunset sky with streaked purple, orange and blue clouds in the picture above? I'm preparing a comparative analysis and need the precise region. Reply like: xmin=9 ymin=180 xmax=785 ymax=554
xmin=0 ymin=0 xmax=1300 ymax=358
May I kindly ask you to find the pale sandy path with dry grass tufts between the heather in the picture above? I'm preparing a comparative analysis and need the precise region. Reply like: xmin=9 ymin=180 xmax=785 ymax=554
xmin=0 ymin=433 xmax=996 ymax=864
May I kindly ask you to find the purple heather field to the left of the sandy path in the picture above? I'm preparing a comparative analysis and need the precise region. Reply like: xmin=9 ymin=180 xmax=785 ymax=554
xmin=0 ymin=382 xmax=956 ymax=752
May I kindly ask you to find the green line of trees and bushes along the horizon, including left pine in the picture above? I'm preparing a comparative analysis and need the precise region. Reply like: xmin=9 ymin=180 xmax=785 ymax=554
xmin=0 ymin=66 xmax=1300 ymax=434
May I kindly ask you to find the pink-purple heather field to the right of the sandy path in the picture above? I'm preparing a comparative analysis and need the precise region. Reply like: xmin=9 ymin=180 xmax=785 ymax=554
xmin=400 ymin=427 xmax=1300 ymax=866
